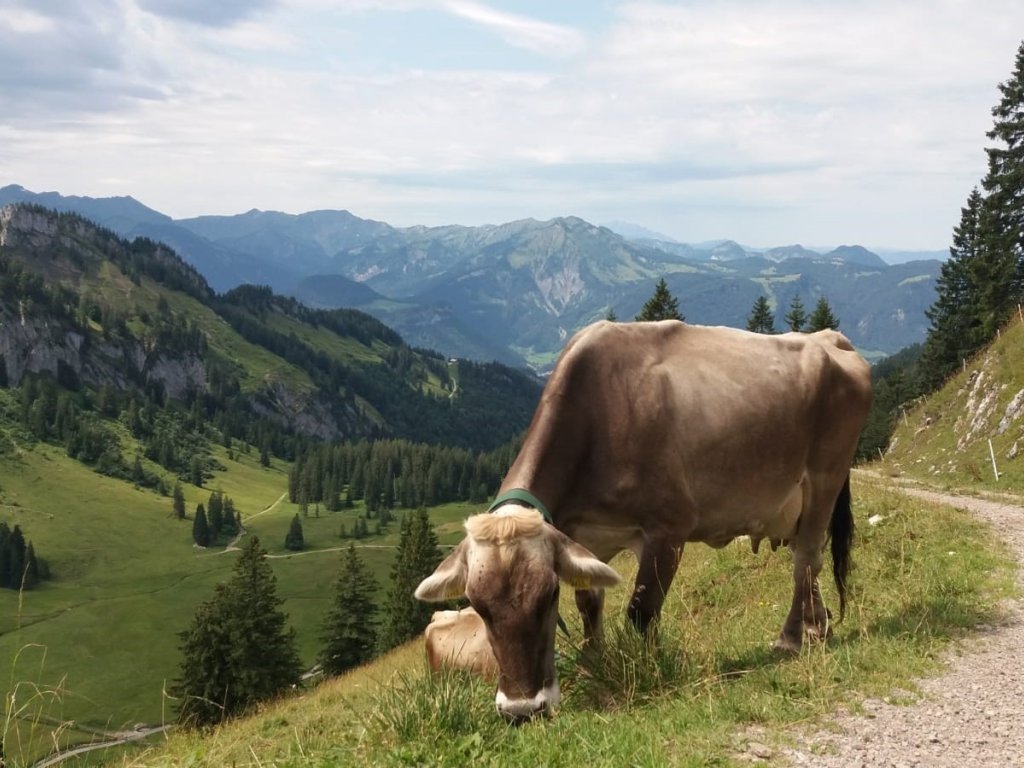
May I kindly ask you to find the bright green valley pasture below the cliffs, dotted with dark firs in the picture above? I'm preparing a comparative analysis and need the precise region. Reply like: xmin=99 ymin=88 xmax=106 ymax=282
xmin=0 ymin=444 xmax=475 ymax=765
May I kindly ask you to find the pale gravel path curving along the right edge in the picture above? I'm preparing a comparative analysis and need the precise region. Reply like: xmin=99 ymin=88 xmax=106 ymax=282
xmin=773 ymin=487 xmax=1024 ymax=768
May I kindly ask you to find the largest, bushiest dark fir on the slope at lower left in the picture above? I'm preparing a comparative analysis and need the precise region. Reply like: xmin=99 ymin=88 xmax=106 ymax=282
xmin=172 ymin=537 xmax=301 ymax=727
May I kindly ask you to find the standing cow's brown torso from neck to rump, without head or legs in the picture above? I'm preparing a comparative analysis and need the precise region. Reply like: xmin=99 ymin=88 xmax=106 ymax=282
xmin=503 ymin=321 xmax=870 ymax=555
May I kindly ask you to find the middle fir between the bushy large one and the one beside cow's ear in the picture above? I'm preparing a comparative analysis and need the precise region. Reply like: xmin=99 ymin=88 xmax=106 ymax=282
xmin=319 ymin=545 xmax=377 ymax=676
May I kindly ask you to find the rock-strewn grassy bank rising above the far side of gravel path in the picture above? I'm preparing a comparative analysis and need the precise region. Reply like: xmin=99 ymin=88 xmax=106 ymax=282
xmin=880 ymin=317 xmax=1024 ymax=493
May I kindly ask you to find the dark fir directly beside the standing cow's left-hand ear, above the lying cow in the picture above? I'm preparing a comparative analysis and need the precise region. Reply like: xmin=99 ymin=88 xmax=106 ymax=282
xmin=380 ymin=507 xmax=441 ymax=650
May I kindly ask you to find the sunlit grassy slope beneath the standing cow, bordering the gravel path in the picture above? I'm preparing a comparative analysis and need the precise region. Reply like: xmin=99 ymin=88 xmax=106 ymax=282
xmin=97 ymin=481 xmax=1013 ymax=766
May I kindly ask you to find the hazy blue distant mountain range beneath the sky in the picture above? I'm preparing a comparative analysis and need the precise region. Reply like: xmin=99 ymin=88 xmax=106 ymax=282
xmin=0 ymin=185 xmax=941 ymax=370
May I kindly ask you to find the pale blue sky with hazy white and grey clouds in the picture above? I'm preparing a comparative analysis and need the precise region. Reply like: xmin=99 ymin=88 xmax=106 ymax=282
xmin=0 ymin=0 xmax=1024 ymax=250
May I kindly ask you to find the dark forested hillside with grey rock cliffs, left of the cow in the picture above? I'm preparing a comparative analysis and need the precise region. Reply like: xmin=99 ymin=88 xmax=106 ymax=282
xmin=0 ymin=201 xmax=539 ymax=462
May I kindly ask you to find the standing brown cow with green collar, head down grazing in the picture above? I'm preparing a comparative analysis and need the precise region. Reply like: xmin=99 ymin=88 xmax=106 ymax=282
xmin=416 ymin=321 xmax=871 ymax=721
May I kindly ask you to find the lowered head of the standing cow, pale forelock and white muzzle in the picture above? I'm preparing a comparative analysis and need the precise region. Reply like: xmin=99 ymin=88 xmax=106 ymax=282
xmin=416 ymin=505 xmax=618 ymax=721
